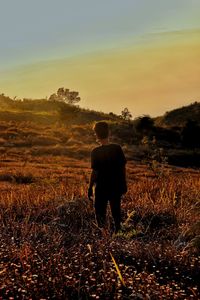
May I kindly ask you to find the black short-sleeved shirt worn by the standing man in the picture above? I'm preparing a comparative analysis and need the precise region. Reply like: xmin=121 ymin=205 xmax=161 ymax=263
xmin=91 ymin=144 xmax=127 ymax=195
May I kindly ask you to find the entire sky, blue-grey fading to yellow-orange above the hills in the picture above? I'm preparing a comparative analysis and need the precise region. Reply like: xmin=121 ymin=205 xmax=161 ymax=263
xmin=0 ymin=0 xmax=200 ymax=117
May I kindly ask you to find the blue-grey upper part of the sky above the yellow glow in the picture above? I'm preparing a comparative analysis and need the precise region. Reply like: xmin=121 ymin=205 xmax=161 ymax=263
xmin=0 ymin=0 xmax=200 ymax=69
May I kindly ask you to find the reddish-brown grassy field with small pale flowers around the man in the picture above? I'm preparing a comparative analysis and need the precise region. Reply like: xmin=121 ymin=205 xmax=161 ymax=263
xmin=0 ymin=151 xmax=200 ymax=299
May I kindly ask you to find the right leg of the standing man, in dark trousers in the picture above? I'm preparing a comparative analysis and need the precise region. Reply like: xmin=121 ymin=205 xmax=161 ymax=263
xmin=110 ymin=196 xmax=121 ymax=233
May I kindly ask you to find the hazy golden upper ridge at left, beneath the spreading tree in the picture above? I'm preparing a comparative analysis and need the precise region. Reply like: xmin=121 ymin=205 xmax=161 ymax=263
xmin=0 ymin=94 xmax=121 ymax=125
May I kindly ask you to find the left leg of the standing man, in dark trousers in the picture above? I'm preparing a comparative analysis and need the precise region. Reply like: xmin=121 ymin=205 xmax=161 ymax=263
xmin=94 ymin=193 xmax=108 ymax=228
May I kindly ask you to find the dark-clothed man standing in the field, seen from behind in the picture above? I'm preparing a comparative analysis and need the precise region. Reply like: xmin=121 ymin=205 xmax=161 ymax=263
xmin=88 ymin=122 xmax=127 ymax=233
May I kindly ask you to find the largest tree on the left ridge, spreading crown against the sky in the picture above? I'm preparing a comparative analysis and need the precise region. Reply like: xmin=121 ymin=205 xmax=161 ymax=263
xmin=49 ymin=87 xmax=81 ymax=104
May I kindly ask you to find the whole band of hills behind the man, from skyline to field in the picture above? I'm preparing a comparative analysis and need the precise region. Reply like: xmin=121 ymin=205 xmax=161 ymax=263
xmin=0 ymin=94 xmax=200 ymax=167
